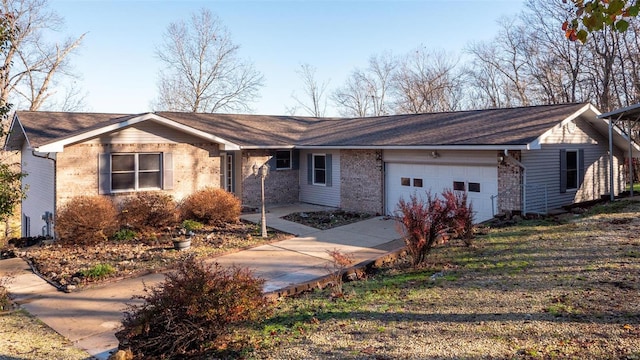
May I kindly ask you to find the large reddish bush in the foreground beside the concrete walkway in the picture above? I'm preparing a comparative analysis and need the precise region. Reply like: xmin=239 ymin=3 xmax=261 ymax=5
xmin=116 ymin=257 xmax=272 ymax=358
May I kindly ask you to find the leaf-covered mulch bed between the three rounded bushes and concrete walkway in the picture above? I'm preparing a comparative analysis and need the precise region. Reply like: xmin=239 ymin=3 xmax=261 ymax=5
xmin=2 ymin=222 xmax=292 ymax=291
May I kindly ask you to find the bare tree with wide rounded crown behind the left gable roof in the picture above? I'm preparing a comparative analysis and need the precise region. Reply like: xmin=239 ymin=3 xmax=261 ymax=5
xmin=155 ymin=9 xmax=264 ymax=113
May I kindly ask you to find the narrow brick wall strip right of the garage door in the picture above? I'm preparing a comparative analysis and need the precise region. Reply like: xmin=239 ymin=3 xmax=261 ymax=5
xmin=498 ymin=151 xmax=522 ymax=212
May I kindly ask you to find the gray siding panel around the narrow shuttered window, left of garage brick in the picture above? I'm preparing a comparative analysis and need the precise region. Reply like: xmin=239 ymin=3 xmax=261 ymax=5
xmin=300 ymin=150 xmax=340 ymax=207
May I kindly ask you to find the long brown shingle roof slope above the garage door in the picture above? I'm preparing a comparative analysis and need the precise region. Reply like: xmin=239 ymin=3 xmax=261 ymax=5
xmin=298 ymin=104 xmax=586 ymax=146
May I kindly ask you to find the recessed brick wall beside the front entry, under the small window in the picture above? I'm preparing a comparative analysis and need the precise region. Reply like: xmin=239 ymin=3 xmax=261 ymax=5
xmin=240 ymin=150 xmax=300 ymax=207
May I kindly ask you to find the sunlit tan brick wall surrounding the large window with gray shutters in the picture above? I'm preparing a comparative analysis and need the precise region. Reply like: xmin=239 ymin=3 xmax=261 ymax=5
xmin=56 ymin=144 xmax=220 ymax=207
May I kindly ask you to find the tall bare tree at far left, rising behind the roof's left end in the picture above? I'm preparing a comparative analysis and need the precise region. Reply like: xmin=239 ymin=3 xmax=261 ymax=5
xmin=0 ymin=0 xmax=84 ymax=111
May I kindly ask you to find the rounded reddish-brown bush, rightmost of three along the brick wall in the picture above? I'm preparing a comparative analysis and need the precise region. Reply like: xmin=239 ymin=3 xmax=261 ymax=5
xmin=180 ymin=187 xmax=241 ymax=225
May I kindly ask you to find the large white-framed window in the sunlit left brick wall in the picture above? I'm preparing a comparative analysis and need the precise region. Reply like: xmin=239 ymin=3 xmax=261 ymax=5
xmin=111 ymin=153 xmax=162 ymax=191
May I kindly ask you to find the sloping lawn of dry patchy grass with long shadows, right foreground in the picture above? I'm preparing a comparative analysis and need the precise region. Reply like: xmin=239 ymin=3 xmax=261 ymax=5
xmin=256 ymin=202 xmax=640 ymax=359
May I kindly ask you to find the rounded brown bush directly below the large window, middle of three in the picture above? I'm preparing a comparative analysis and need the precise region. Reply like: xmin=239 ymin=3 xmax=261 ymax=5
xmin=120 ymin=192 xmax=177 ymax=231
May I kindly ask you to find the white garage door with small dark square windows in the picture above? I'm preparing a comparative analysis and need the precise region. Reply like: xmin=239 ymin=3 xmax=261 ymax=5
xmin=385 ymin=163 xmax=498 ymax=222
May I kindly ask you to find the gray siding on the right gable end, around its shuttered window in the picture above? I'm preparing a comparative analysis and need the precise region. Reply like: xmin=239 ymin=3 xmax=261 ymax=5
xmin=522 ymin=118 xmax=621 ymax=209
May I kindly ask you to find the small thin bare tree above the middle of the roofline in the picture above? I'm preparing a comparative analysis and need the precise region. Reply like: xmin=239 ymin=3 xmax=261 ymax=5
xmin=287 ymin=64 xmax=329 ymax=117
